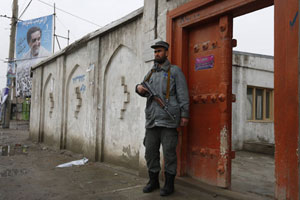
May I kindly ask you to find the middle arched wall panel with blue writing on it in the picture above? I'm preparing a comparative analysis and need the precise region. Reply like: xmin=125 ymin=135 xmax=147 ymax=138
xmin=63 ymin=38 xmax=99 ymax=157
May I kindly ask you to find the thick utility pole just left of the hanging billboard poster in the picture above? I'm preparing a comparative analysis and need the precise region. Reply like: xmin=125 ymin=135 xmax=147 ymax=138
xmin=2 ymin=0 xmax=18 ymax=128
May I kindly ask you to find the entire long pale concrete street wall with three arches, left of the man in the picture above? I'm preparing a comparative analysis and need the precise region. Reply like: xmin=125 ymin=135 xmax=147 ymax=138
xmin=30 ymin=0 xmax=195 ymax=173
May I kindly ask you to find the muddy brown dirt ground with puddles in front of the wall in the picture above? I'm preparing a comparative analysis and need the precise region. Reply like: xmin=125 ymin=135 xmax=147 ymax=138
xmin=0 ymin=129 xmax=230 ymax=200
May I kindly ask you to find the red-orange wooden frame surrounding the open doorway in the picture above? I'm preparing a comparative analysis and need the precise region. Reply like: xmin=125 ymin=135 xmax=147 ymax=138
xmin=166 ymin=0 xmax=300 ymax=199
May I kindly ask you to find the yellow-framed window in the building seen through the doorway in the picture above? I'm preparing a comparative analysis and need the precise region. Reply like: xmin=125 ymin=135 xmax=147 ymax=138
xmin=246 ymin=86 xmax=273 ymax=121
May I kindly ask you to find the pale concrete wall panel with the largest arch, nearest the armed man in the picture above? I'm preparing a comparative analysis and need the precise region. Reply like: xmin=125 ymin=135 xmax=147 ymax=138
xmin=99 ymin=18 xmax=145 ymax=169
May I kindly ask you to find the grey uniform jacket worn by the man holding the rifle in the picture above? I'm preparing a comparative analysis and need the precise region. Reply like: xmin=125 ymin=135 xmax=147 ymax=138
xmin=136 ymin=60 xmax=189 ymax=128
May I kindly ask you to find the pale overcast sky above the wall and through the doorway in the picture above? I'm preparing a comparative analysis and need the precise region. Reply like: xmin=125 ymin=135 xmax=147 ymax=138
xmin=0 ymin=0 xmax=274 ymax=88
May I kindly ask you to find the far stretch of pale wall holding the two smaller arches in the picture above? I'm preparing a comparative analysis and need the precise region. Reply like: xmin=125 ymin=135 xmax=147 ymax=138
xmin=30 ymin=38 xmax=99 ymax=157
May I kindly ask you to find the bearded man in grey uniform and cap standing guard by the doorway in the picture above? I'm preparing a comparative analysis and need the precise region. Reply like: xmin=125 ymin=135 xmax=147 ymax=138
xmin=136 ymin=41 xmax=189 ymax=196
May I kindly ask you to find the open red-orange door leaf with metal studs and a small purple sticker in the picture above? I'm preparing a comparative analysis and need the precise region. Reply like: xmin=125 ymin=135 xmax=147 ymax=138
xmin=186 ymin=16 xmax=232 ymax=187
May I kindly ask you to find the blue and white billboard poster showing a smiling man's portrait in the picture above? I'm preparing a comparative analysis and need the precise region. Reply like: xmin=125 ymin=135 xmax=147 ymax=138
xmin=15 ymin=15 xmax=53 ymax=97
